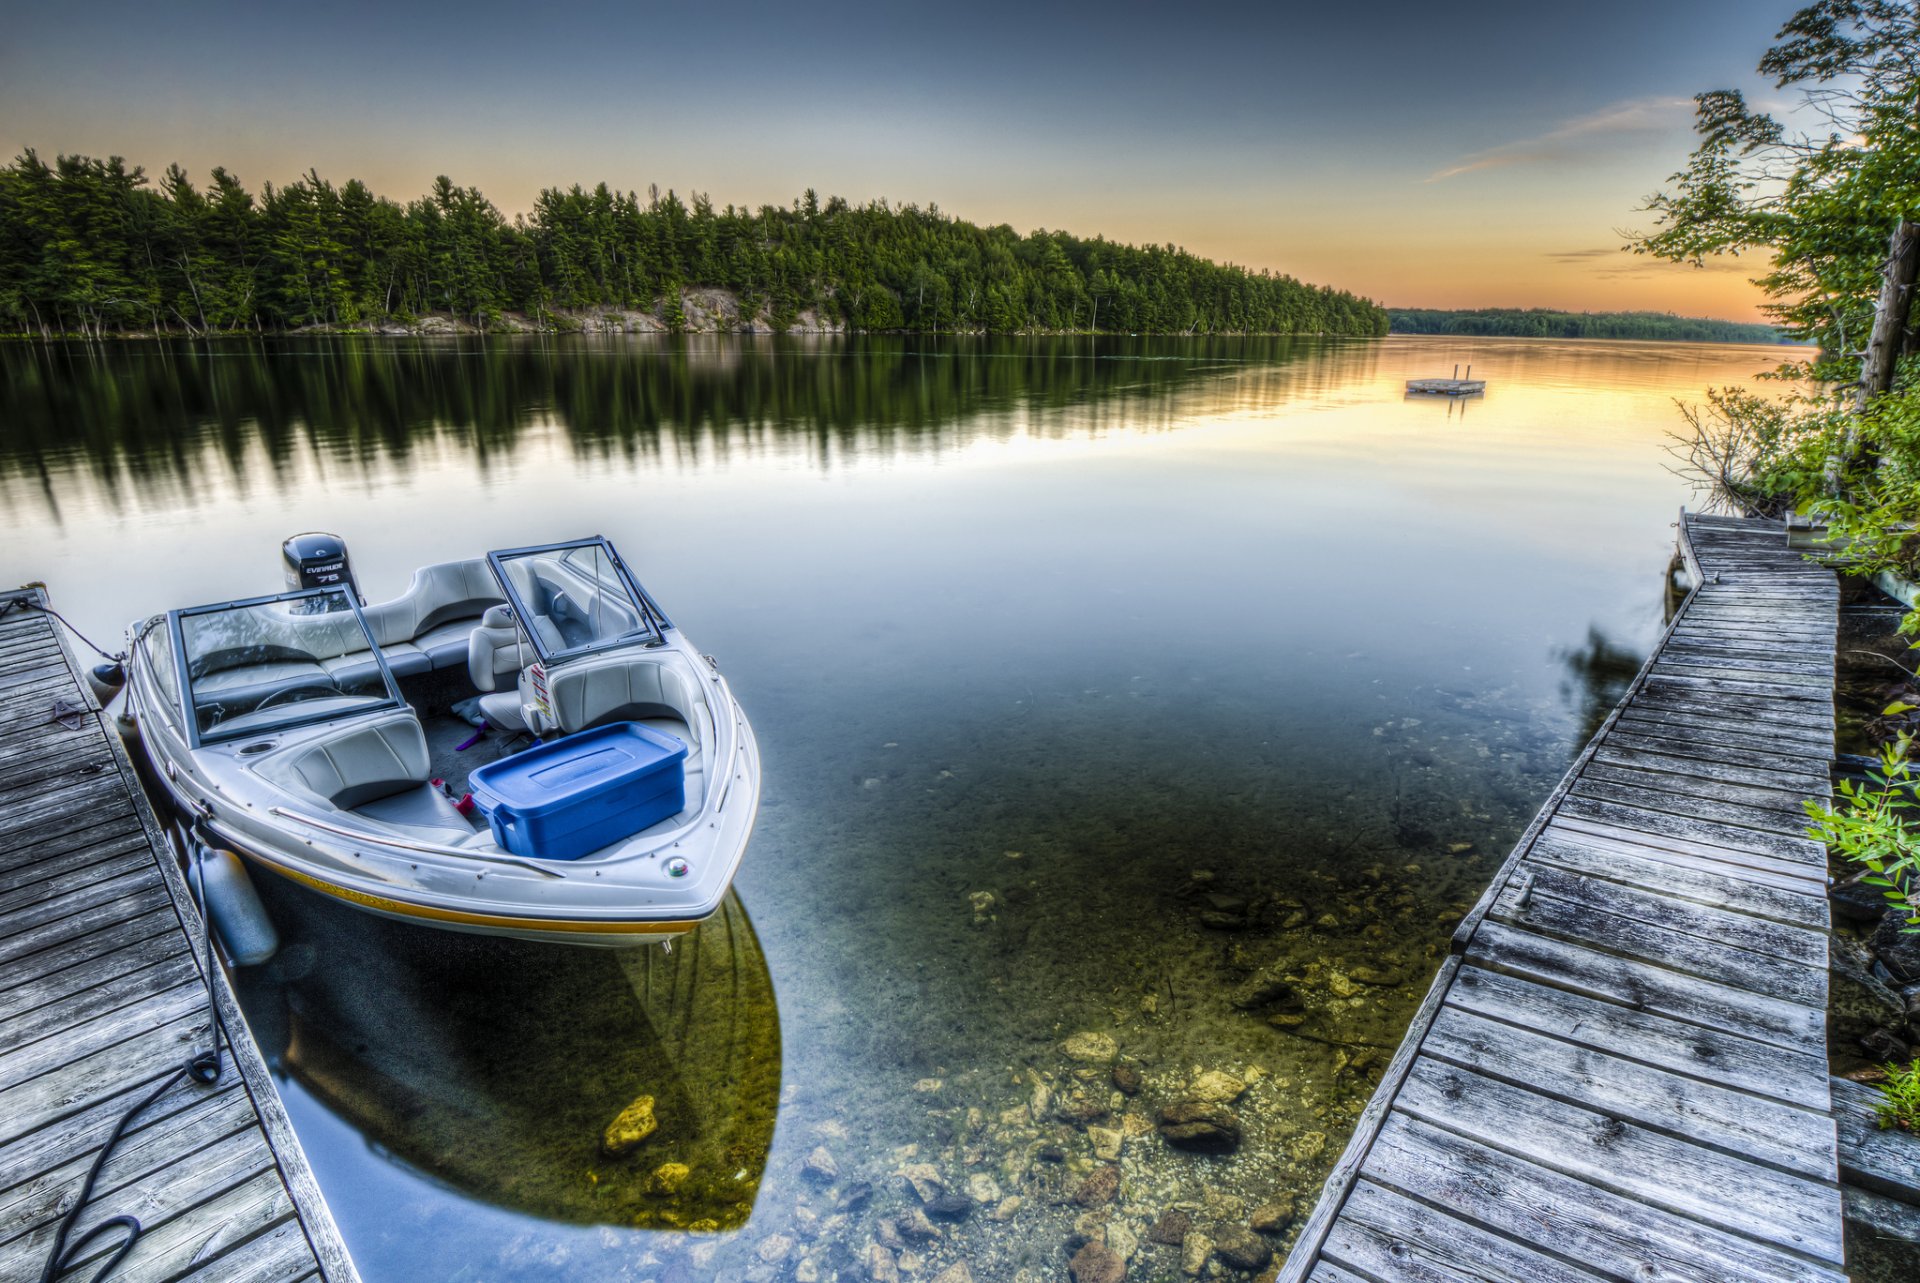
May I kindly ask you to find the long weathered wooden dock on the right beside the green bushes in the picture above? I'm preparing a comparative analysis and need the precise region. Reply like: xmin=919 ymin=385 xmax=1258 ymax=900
xmin=1279 ymin=515 xmax=1845 ymax=1283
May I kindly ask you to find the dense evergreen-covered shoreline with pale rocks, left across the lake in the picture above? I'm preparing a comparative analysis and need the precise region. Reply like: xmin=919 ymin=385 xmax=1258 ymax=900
xmin=0 ymin=152 xmax=1386 ymax=338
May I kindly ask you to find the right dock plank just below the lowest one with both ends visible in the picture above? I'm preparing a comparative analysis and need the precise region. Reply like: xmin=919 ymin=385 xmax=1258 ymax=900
xmin=1367 ymin=1114 xmax=1843 ymax=1283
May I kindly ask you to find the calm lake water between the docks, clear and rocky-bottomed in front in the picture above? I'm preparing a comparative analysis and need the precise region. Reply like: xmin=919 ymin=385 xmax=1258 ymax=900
xmin=0 ymin=340 xmax=1782 ymax=1283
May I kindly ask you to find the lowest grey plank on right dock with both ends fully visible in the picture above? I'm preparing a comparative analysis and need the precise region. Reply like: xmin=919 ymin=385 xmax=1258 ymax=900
xmin=1394 ymin=1058 xmax=1841 ymax=1264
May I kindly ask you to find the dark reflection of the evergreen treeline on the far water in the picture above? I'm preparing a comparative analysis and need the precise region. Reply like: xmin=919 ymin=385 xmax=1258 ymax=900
xmin=0 ymin=336 xmax=1379 ymax=514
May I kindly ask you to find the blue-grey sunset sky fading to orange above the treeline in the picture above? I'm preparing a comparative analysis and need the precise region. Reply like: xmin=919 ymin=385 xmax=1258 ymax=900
xmin=0 ymin=0 xmax=1801 ymax=321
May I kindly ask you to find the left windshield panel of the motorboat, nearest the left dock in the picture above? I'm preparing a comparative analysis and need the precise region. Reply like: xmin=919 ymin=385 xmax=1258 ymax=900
xmin=171 ymin=588 xmax=399 ymax=743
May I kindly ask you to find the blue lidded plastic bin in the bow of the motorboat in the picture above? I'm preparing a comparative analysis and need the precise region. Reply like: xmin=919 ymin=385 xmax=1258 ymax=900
xmin=467 ymin=722 xmax=687 ymax=860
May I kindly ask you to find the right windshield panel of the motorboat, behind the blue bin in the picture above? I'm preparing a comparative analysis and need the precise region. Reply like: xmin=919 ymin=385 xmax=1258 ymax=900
xmin=488 ymin=538 xmax=666 ymax=661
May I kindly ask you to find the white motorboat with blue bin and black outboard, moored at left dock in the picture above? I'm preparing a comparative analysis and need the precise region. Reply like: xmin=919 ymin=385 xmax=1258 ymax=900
xmin=127 ymin=536 xmax=760 ymax=947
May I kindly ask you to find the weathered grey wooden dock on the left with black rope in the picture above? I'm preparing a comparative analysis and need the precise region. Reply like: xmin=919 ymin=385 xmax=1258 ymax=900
xmin=0 ymin=593 xmax=359 ymax=1283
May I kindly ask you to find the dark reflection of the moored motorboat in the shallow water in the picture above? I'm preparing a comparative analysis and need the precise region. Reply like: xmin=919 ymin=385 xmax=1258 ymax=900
xmin=240 ymin=878 xmax=780 ymax=1231
